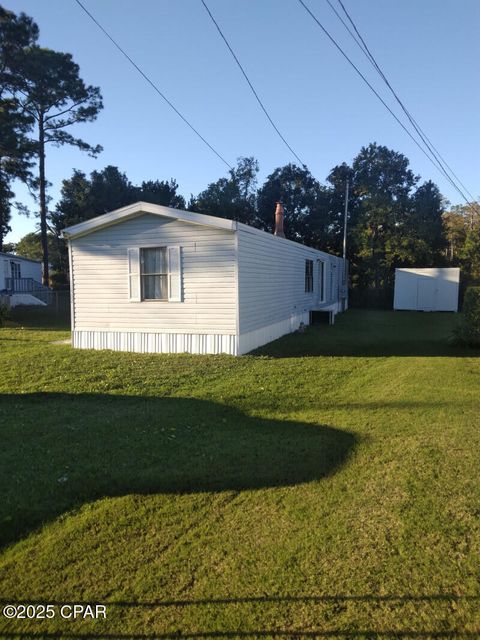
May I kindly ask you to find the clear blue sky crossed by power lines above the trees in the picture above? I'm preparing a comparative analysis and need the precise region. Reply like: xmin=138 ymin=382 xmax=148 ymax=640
xmin=3 ymin=0 xmax=480 ymax=241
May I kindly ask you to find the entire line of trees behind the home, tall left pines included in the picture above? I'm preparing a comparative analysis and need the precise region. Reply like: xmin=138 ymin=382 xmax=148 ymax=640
xmin=0 ymin=6 xmax=480 ymax=299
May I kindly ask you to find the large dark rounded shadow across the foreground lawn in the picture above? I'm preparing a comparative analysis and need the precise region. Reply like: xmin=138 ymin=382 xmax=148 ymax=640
xmin=0 ymin=393 xmax=356 ymax=545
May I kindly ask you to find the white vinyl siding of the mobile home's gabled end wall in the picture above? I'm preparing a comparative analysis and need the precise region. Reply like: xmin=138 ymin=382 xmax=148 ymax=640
xmin=71 ymin=214 xmax=237 ymax=335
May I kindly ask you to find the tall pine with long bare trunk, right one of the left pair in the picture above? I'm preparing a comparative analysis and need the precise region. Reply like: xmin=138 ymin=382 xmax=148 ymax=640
xmin=14 ymin=45 xmax=103 ymax=284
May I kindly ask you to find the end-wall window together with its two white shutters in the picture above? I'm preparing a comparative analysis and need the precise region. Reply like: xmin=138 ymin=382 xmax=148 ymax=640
xmin=128 ymin=246 xmax=182 ymax=302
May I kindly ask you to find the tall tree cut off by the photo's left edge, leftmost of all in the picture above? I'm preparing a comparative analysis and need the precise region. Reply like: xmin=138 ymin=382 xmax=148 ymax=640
xmin=0 ymin=5 xmax=38 ymax=250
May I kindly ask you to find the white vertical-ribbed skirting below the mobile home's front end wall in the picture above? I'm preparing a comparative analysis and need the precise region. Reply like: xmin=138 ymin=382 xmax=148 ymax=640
xmin=72 ymin=331 xmax=237 ymax=356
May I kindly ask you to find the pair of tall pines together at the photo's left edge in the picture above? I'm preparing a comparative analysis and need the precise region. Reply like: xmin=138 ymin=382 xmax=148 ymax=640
xmin=0 ymin=6 xmax=103 ymax=284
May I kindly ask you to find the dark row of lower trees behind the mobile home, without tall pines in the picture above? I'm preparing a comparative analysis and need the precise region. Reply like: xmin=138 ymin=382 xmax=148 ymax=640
xmin=10 ymin=143 xmax=480 ymax=301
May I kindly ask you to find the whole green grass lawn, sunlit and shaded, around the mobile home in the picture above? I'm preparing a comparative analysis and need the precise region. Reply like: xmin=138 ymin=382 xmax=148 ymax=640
xmin=0 ymin=311 xmax=480 ymax=639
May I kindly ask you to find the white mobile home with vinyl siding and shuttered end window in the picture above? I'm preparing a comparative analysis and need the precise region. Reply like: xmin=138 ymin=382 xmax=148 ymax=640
xmin=64 ymin=202 xmax=346 ymax=355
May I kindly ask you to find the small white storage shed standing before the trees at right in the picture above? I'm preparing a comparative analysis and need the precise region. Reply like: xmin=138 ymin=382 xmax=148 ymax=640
xmin=393 ymin=268 xmax=460 ymax=311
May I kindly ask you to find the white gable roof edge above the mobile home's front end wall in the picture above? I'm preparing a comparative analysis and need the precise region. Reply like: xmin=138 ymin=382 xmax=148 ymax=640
xmin=63 ymin=202 xmax=237 ymax=238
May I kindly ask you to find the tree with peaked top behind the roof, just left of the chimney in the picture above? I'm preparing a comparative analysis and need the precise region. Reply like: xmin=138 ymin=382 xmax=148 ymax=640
xmin=193 ymin=157 xmax=258 ymax=225
